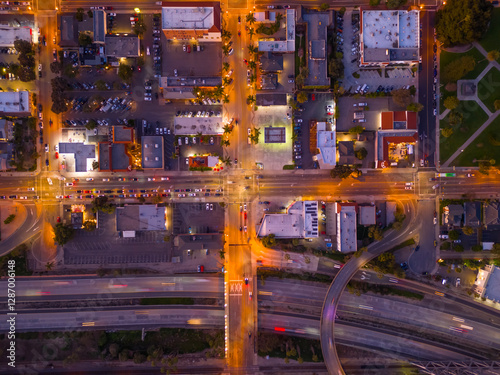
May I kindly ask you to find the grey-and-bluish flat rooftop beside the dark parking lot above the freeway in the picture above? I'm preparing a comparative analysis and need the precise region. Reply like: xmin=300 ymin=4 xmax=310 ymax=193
xmin=116 ymin=205 xmax=166 ymax=231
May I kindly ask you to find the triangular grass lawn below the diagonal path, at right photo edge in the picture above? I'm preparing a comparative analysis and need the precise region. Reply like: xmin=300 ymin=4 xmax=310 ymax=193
xmin=452 ymin=112 xmax=500 ymax=167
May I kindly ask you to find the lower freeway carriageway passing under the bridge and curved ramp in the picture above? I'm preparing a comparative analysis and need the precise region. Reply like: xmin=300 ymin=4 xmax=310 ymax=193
xmin=0 ymin=306 xmax=481 ymax=360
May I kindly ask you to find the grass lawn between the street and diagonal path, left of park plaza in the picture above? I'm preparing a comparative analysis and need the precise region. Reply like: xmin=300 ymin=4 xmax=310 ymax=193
xmin=439 ymin=100 xmax=488 ymax=163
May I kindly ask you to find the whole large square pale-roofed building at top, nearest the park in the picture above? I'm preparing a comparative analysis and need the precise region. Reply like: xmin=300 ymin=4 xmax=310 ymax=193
xmin=359 ymin=10 xmax=420 ymax=66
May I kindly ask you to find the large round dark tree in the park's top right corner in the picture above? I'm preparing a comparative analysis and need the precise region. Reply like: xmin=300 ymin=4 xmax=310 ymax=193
xmin=436 ymin=0 xmax=493 ymax=48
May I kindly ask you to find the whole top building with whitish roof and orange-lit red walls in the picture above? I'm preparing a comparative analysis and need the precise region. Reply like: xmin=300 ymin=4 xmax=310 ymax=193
xmin=162 ymin=2 xmax=222 ymax=42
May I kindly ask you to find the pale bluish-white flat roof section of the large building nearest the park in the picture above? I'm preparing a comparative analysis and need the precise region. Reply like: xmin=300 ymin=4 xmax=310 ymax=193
xmin=361 ymin=10 xmax=420 ymax=49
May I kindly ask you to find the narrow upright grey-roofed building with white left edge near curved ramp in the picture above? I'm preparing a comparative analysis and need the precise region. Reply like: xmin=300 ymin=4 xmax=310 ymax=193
xmin=335 ymin=202 xmax=358 ymax=253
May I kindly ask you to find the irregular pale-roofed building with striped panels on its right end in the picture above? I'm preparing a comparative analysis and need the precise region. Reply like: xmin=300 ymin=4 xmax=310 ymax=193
xmin=257 ymin=201 xmax=318 ymax=238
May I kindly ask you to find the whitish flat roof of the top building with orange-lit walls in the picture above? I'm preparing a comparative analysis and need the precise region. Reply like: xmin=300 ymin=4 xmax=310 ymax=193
xmin=161 ymin=7 xmax=214 ymax=30
